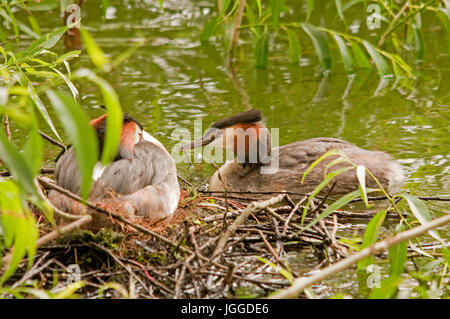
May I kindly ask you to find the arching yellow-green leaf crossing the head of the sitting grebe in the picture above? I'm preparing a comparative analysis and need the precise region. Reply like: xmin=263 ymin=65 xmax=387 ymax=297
xmin=74 ymin=69 xmax=123 ymax=165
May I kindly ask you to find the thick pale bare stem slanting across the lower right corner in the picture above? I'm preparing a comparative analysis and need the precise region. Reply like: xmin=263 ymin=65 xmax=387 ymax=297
xmin=269 ymin=214 xmax=450 ymax=299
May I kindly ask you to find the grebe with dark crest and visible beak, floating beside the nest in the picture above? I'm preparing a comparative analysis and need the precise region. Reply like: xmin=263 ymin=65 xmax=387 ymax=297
xmin=181 ymin=110 xmax=404 ymax=197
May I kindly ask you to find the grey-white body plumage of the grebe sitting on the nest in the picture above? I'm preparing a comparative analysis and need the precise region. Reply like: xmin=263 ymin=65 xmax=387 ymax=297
xmin=51 ymin=140 xmax=180 ymax=218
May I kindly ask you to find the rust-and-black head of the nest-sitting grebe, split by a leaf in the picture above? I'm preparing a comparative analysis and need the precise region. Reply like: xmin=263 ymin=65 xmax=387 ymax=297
xmin=89 ymin=113 xmax=143 ymax=158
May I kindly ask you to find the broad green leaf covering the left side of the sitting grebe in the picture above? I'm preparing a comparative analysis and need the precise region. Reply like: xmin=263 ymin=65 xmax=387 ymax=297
xmin=47 ymin=90 xmax=98 ymax=199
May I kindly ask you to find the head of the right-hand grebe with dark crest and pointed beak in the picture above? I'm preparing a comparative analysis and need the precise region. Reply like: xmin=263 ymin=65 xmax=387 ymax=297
xmin=181 ymin=110 xmax=271 ymax=164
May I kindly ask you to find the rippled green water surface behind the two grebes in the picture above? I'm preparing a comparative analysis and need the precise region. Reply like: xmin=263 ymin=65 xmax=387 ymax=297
xmin=16 ymin=0 xmax=450 ymax=300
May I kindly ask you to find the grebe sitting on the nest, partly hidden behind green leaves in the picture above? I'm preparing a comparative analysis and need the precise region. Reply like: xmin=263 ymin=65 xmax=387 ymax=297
xmin=49 ymin=114 xmax=180 ymax=220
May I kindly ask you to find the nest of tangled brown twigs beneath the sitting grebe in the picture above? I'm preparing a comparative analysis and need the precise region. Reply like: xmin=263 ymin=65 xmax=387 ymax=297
xmin=2 ymin=183 xmax=404 ymax=298
